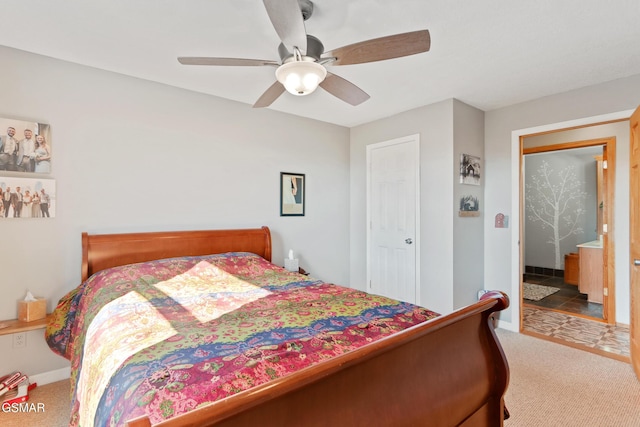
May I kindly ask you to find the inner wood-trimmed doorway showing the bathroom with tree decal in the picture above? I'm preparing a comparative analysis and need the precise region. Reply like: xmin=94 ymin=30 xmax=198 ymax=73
xmin=522 ymin=142 xmax=615 ymax=326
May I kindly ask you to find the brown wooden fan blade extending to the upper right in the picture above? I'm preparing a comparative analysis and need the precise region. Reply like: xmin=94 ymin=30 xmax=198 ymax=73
xmin=322 ymin=30 xmax=431 ymax=65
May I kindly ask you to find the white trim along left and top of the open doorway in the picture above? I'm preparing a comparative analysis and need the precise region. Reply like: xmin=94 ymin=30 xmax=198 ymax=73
xmin=500 ymin=110 xmax=634 ymax=332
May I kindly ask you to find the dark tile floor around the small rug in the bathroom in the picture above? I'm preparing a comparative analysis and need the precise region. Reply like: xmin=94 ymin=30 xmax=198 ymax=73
xmin=523 ymin=274 xmax=602 ymax=319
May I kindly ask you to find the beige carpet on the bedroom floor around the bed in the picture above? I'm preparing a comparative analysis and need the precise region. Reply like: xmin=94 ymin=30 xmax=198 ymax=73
xmin=0 ymin=329 xmax=640 ymax=427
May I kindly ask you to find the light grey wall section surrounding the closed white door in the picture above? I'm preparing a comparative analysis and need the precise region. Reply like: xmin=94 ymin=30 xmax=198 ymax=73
xmin=350 ymin=99 xmax=482 ymax=313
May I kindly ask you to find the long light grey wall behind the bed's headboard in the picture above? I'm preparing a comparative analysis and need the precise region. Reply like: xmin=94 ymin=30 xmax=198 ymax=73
xmin=0 ymin=47 xmax=349 ymax=375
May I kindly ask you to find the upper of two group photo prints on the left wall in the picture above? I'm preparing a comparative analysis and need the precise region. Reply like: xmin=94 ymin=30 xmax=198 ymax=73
xmin=0 ymin=117 xmax=52 ymax=174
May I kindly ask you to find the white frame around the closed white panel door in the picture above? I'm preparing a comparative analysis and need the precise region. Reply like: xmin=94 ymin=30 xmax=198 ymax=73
xmin=366 ymin=134 xmax=422 ymax=305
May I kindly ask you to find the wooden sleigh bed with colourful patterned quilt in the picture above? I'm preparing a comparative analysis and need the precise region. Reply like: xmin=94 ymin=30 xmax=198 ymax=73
xmin=46 ymin=227 xmax=509 ymax=427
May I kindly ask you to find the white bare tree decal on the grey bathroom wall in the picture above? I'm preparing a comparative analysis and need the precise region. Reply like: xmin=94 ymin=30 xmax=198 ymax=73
xmin=525 ymin=161 xmax=587 ymax=269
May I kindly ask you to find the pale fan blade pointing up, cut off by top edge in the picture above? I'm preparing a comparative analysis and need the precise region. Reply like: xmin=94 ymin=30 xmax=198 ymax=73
xmin=263 ymin=0 xmax=307 ymax=55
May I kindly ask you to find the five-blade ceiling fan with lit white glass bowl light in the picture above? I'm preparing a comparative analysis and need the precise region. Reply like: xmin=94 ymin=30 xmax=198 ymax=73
xmin=178 ymin=0 xmax=431 ymax=108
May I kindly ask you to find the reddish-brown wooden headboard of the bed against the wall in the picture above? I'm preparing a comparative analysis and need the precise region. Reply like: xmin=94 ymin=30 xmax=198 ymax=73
xmin=82 ymin=227 xmax=271 ymax=282
